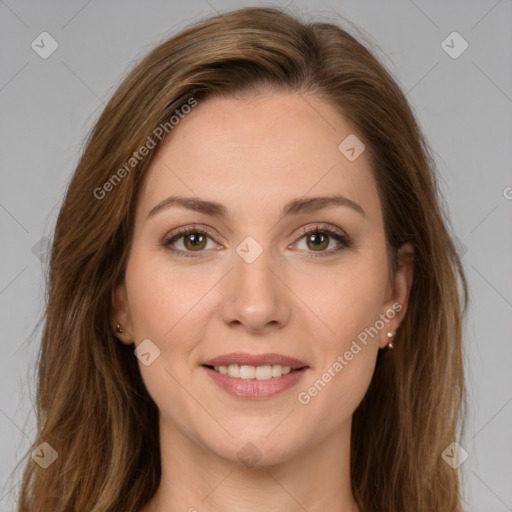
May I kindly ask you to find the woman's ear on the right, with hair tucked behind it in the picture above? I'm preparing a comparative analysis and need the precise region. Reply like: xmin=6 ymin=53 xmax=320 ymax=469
xmin=379 ymin=243 xmax=414 ymax=348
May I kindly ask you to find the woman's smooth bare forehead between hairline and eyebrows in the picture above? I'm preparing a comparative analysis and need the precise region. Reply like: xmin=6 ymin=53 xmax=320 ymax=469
xmin=138 ymin=93 xmax=380 ymax=224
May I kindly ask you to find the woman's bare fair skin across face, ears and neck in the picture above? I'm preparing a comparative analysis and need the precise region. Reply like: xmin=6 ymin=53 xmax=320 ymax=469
xmin=112 ymin=92 xmax=413 ymax=512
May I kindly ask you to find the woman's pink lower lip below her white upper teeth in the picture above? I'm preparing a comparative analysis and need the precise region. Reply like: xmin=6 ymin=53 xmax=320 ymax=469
xmin=203 ymin=366 xmax=307 ymax=400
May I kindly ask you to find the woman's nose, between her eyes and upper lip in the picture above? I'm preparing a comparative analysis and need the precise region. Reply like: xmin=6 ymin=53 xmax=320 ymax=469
xmin=222 ymin=245 xmax=291 ymax=333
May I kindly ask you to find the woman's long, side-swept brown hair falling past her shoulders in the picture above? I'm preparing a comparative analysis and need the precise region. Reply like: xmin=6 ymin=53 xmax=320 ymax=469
xmin=13 ymin=8 xmax=468 ymax=512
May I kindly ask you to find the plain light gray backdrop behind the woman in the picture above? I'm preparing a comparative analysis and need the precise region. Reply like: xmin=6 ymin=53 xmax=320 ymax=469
xmin=0 ymin=0 xmax=512 ymax=512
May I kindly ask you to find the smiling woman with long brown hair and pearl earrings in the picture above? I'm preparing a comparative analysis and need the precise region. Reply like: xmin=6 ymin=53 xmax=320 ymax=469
xmin=15 ymin=8 xmax=467 ymax=512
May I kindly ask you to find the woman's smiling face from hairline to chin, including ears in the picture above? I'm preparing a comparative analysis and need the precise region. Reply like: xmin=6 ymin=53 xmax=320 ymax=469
xmin=113 ymin=93 xmax=412 ymax=464
